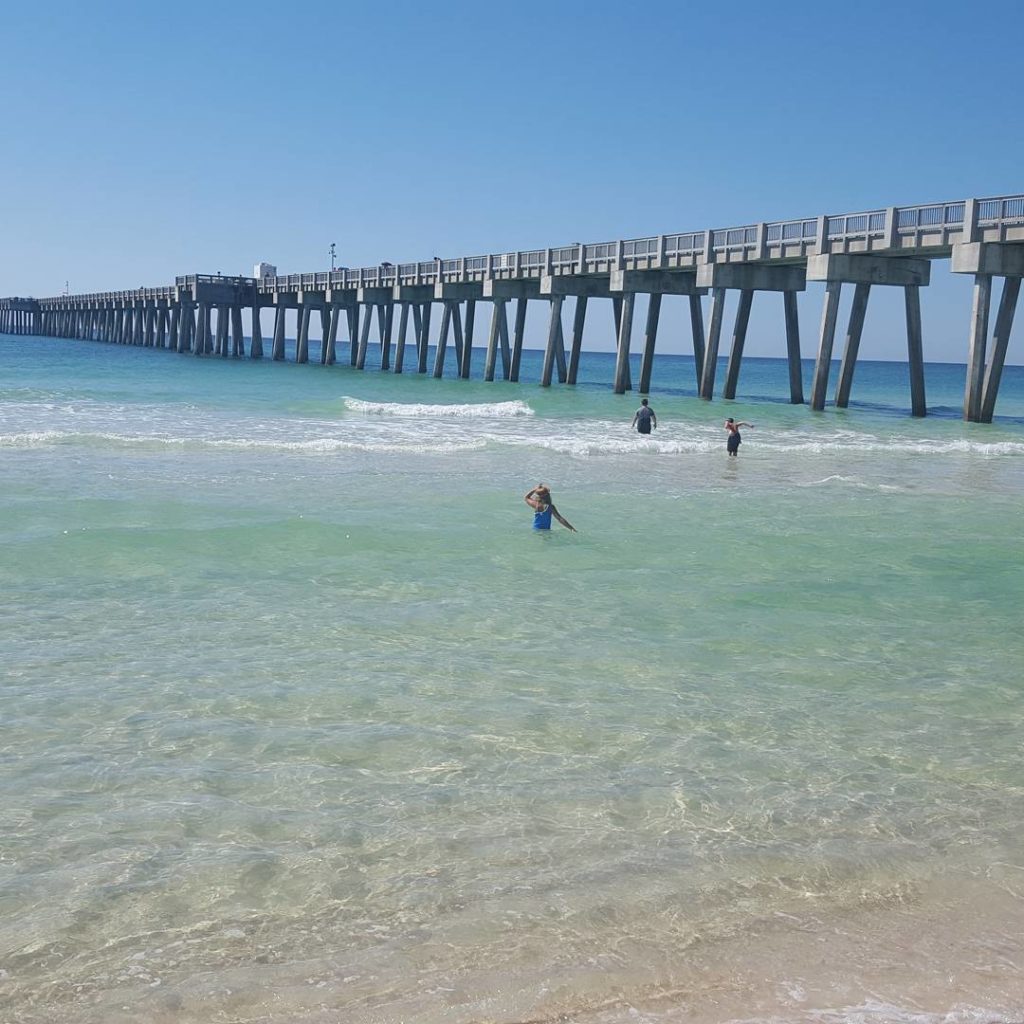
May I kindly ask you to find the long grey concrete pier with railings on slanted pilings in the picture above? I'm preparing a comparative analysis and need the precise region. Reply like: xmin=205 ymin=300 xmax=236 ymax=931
xmin=0 ymin=196 xmax=1024 ymax=423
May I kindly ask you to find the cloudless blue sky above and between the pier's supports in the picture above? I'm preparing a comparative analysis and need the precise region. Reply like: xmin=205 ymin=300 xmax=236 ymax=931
xmin=0 ymin=0 xmax=1024 ymax=362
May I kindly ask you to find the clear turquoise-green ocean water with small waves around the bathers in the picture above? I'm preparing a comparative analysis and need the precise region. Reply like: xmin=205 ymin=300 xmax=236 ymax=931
xmin=0 ymin=337 xmax=1024 ymax=1024
